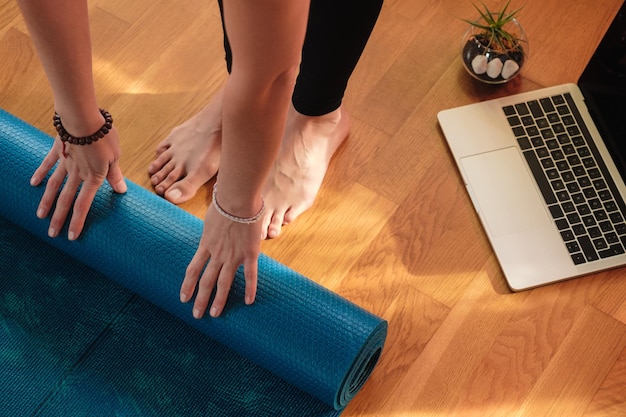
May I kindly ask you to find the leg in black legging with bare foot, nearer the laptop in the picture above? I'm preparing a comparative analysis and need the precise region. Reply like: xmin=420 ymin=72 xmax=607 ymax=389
xmin=263 ymin=0 xmax=382 ymax=238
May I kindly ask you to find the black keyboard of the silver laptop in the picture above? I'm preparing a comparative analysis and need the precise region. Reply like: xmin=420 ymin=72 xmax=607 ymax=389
xmin=503 ymin=93 xmax=626 ymax=265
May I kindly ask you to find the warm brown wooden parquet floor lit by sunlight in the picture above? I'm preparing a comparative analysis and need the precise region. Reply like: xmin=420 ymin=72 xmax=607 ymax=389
xmin=0 ymin=0 xmax=626 ymax=417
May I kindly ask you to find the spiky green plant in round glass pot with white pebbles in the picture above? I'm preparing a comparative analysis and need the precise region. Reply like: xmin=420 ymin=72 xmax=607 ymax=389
xmin=462 ymin=0 xmax=528 ymax=84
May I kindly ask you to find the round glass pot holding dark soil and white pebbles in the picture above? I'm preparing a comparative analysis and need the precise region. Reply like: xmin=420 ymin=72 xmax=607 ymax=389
xmin=461 ymin=19 xmax=528 ymax=84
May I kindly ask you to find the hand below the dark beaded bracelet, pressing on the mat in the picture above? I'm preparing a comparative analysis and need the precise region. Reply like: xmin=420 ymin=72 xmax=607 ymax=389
xmin=30 ymin=127 xmax=127 ymax=240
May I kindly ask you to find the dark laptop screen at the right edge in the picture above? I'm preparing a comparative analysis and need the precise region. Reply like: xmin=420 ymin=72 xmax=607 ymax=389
xmin=578 ymin=3 xmax=626 ymax=176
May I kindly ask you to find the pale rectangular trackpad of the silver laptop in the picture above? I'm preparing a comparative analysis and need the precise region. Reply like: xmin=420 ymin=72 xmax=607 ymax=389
xmin=461 ymin=147 xmax=552 ymax=236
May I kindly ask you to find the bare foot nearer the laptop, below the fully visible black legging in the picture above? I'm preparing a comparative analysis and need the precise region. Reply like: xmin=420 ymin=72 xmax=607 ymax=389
xmin=263 ymin=106 xmax=350 ymax=239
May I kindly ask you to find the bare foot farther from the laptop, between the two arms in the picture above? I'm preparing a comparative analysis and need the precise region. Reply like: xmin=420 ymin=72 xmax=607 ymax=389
xmin=148 ymin=91 xmax=223 ymax=204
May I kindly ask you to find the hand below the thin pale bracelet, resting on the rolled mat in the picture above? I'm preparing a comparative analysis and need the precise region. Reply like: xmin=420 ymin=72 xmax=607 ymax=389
xmin=180 ymin=204 xmax=261 ymax=319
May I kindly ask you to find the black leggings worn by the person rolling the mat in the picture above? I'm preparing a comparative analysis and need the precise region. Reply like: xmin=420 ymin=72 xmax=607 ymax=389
xmin=218 ymin=0 xmax=383 ymax=116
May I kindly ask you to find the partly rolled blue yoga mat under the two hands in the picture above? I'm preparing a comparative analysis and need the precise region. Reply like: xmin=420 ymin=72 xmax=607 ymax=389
xmin=0 ymin=110 xmax=387 ymax=417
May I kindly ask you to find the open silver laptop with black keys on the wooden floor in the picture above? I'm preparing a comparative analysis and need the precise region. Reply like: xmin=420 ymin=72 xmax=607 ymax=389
xmin=438 ymin=1 xmax=626 ymax=291
